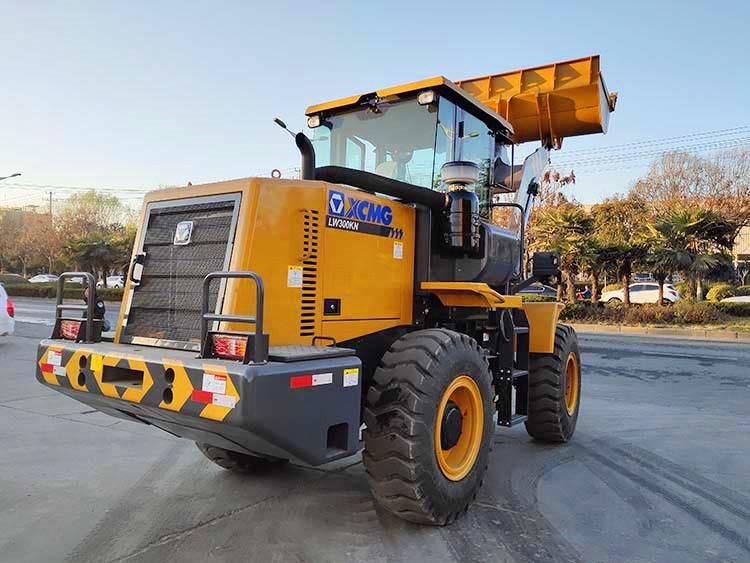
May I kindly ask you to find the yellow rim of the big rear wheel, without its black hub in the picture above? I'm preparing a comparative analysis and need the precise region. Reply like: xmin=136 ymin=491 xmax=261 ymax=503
xmin=435 ymin=375 xmax=484 ymax=481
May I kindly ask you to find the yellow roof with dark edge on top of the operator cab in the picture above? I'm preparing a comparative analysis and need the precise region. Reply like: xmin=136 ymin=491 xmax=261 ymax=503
xmin=305 ymin=76 xmax=513 ymax=138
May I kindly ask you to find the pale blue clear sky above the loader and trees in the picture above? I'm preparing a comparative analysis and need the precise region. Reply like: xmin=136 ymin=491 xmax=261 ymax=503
xmin=0 ymin=0 xmax=750 ymax=206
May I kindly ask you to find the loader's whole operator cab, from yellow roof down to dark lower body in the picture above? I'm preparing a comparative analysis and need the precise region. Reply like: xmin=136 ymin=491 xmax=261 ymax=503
xmin=306 ymin=77 xmax=548 ymax=291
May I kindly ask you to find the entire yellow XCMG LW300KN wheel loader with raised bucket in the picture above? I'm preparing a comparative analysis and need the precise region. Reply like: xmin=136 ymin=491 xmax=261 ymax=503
xmin=36 ymin=56 xmax=615 ymax=525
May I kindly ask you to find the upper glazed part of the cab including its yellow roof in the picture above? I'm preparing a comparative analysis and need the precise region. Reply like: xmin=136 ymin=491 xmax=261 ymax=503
xmin=306 ymin=77 xmax=517 ymax=225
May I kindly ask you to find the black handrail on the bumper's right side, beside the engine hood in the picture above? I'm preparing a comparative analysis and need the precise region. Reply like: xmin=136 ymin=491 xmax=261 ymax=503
xmin=201 ymin=272 xmax=268 ymax=363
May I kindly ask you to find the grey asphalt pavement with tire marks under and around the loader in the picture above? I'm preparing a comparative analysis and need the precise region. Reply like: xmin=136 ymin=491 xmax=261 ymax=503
xmin=0 ymin=312 xmax=750 ymax=563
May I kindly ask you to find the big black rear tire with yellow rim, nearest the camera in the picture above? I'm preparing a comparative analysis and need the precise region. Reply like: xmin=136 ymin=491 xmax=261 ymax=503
xmin=363 ymin=329 xmax=494 ymax=526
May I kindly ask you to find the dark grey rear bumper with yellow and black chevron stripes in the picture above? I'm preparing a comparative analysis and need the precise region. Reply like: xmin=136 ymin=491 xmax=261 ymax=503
xmin=36 ymin=340 xmax=362 ymax=465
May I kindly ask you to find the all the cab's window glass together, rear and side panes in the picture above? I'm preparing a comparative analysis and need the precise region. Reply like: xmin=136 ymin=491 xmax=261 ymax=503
xmin=312 ymin=96 xmax=525 ymax=223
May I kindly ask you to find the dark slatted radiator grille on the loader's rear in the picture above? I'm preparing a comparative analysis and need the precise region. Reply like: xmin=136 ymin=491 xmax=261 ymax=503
xmin=125 ymin=197 xmax=238 ymax=348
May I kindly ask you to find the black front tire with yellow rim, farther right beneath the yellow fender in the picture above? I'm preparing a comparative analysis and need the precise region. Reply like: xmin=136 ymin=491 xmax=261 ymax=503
xmin=526 ymin=325 xmax=581 ymax=442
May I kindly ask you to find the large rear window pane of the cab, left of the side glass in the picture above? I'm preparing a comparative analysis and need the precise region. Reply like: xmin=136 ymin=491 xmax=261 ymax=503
xmin=312 ymin=98 xmax=437 ymax=188
